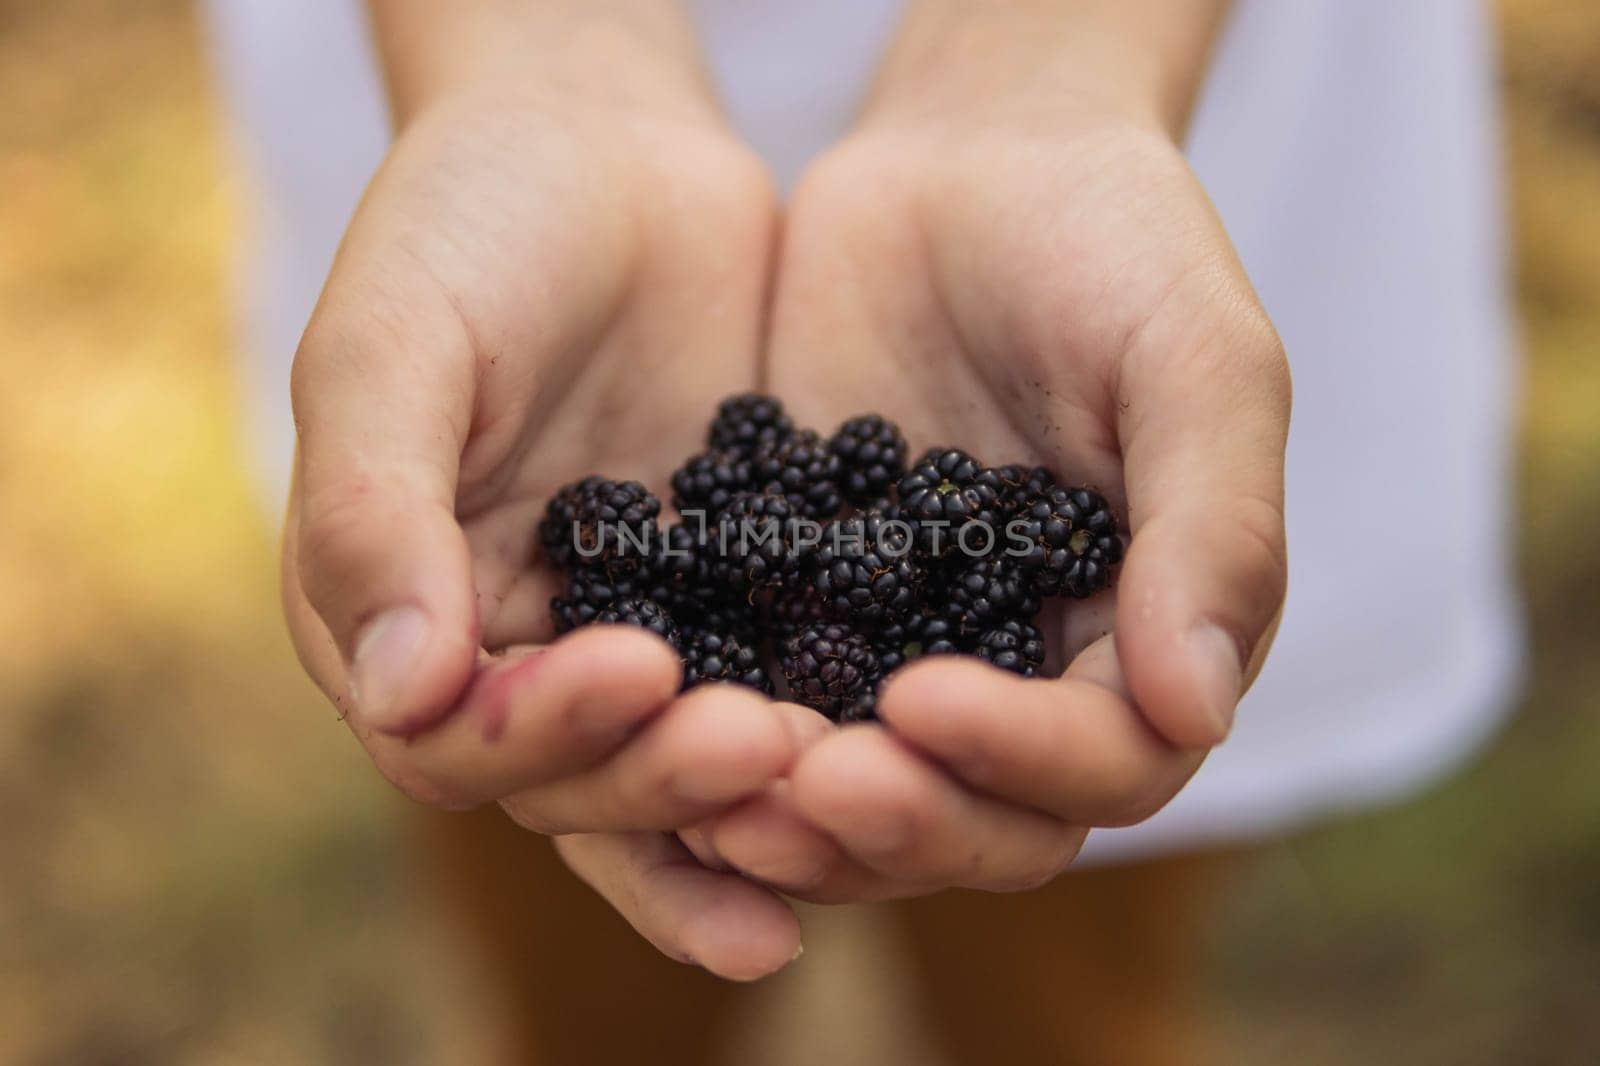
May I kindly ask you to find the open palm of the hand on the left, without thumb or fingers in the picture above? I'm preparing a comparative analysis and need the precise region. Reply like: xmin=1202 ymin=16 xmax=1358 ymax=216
xmin=296 ymin=97 xmax=787 ymax=665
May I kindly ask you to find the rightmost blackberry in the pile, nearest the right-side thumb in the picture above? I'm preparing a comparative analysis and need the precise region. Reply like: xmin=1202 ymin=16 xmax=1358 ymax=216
xmin=1018 ymin=487 xmax=1123 ymax=599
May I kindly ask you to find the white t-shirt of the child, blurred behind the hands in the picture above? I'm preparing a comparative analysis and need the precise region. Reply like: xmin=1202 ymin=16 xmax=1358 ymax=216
xmin=210 ymin=0 xmax=1520 ymax=856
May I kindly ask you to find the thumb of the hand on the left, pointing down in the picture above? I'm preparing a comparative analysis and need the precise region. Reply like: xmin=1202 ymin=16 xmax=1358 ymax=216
xmin=285 ymin=283 xmax=478 ymax=733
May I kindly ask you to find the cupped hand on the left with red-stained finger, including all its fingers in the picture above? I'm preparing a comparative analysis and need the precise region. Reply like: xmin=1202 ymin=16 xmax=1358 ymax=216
xmin=283 ymin=12 xmax=802 ymax=978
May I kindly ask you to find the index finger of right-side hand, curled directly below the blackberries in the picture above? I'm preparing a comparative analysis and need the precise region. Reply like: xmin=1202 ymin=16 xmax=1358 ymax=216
xmin=878 ymin=637 xmax=1205 ymax=826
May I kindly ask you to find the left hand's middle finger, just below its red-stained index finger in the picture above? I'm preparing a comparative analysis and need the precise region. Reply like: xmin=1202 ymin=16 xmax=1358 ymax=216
xmin=501 ymin=685 xmax=800 ymax=834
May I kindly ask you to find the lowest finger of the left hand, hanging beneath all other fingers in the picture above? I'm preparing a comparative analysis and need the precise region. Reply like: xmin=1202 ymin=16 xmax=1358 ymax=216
xmin=555 ymin=832 xmax=802 ymax=981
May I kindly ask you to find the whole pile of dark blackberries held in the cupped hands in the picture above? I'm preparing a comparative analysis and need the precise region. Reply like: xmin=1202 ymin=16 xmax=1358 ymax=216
xmin=539 ymin=394 xmax=1123 ymax=722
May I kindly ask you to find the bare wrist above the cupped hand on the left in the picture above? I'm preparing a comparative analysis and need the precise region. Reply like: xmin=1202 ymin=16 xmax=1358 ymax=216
xmin=370 ymin=0 xmax=720 ymax=126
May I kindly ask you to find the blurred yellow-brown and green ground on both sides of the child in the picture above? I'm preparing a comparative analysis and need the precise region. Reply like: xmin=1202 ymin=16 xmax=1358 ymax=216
xmin=0 ymin=0 xmax=1600 ymax=1066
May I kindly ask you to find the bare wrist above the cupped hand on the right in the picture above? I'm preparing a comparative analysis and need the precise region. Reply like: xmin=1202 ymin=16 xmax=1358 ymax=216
xmin=862 ymin=0 xmax=1229 ymax=141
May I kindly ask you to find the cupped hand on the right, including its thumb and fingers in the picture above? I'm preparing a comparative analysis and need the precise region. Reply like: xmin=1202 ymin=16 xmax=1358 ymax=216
xmin=685 ymin=102 xmax=1290 ymax=901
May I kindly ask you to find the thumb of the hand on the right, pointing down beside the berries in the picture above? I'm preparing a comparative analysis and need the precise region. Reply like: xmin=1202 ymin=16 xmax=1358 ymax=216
xmin=1117 ymin=280 xmax=1290 ymax=747
